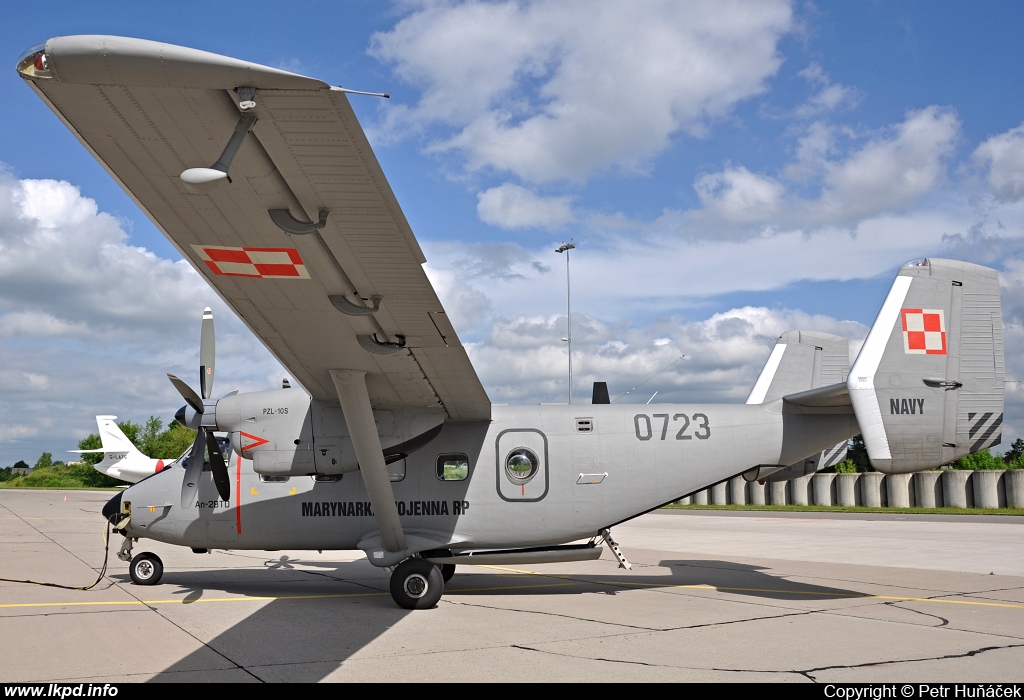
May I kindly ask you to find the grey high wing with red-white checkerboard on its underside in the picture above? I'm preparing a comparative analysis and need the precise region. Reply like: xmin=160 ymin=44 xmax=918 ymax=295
xmin=18 ymin=36 xmax=490 ymax=421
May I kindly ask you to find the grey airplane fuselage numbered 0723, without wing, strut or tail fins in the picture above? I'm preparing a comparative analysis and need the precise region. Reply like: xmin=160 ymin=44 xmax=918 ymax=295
xmin=123 ymin=401 xmax=857 ymax=550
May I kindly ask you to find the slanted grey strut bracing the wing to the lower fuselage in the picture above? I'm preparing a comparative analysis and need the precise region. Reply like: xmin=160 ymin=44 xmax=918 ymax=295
xmin=331 ymin=369 xmax=406 ymax=552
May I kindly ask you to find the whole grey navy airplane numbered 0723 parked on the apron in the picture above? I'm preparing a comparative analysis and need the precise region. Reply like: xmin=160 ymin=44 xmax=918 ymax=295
xmin=17 ymin=36 xmax=1004 ymax=608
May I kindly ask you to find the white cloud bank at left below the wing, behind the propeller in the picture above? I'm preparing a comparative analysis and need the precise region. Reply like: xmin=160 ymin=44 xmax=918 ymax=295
xmin=0 ymin=169 xmax=284 ymax=467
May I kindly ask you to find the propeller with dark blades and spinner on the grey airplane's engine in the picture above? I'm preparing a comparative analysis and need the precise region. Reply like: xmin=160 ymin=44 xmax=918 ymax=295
xmin=167 ymin=307 xmax=231 ymax=508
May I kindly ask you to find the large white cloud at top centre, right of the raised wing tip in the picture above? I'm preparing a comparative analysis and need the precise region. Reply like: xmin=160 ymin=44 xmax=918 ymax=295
xmin=371 ymin=0 xmax=794 ymax=182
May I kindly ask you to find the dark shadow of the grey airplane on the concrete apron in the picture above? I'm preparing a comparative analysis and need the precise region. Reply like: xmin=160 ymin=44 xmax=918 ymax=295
xmin=112 ymin=556 xmax=864 ymax=682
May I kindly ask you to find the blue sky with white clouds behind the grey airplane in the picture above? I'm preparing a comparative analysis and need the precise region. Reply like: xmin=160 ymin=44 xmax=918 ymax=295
xmin=0 ymin=0 xmax=1024 ymax=466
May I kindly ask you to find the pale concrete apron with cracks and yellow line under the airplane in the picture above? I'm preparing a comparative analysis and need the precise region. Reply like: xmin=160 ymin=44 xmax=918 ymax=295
xmin=0 ymin=490 xmax=1024 ymax=683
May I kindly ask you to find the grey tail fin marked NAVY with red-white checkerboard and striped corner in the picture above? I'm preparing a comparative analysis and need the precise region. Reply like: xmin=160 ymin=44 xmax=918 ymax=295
xmin=847 ymin=258 xmax=1004 ymax=473
